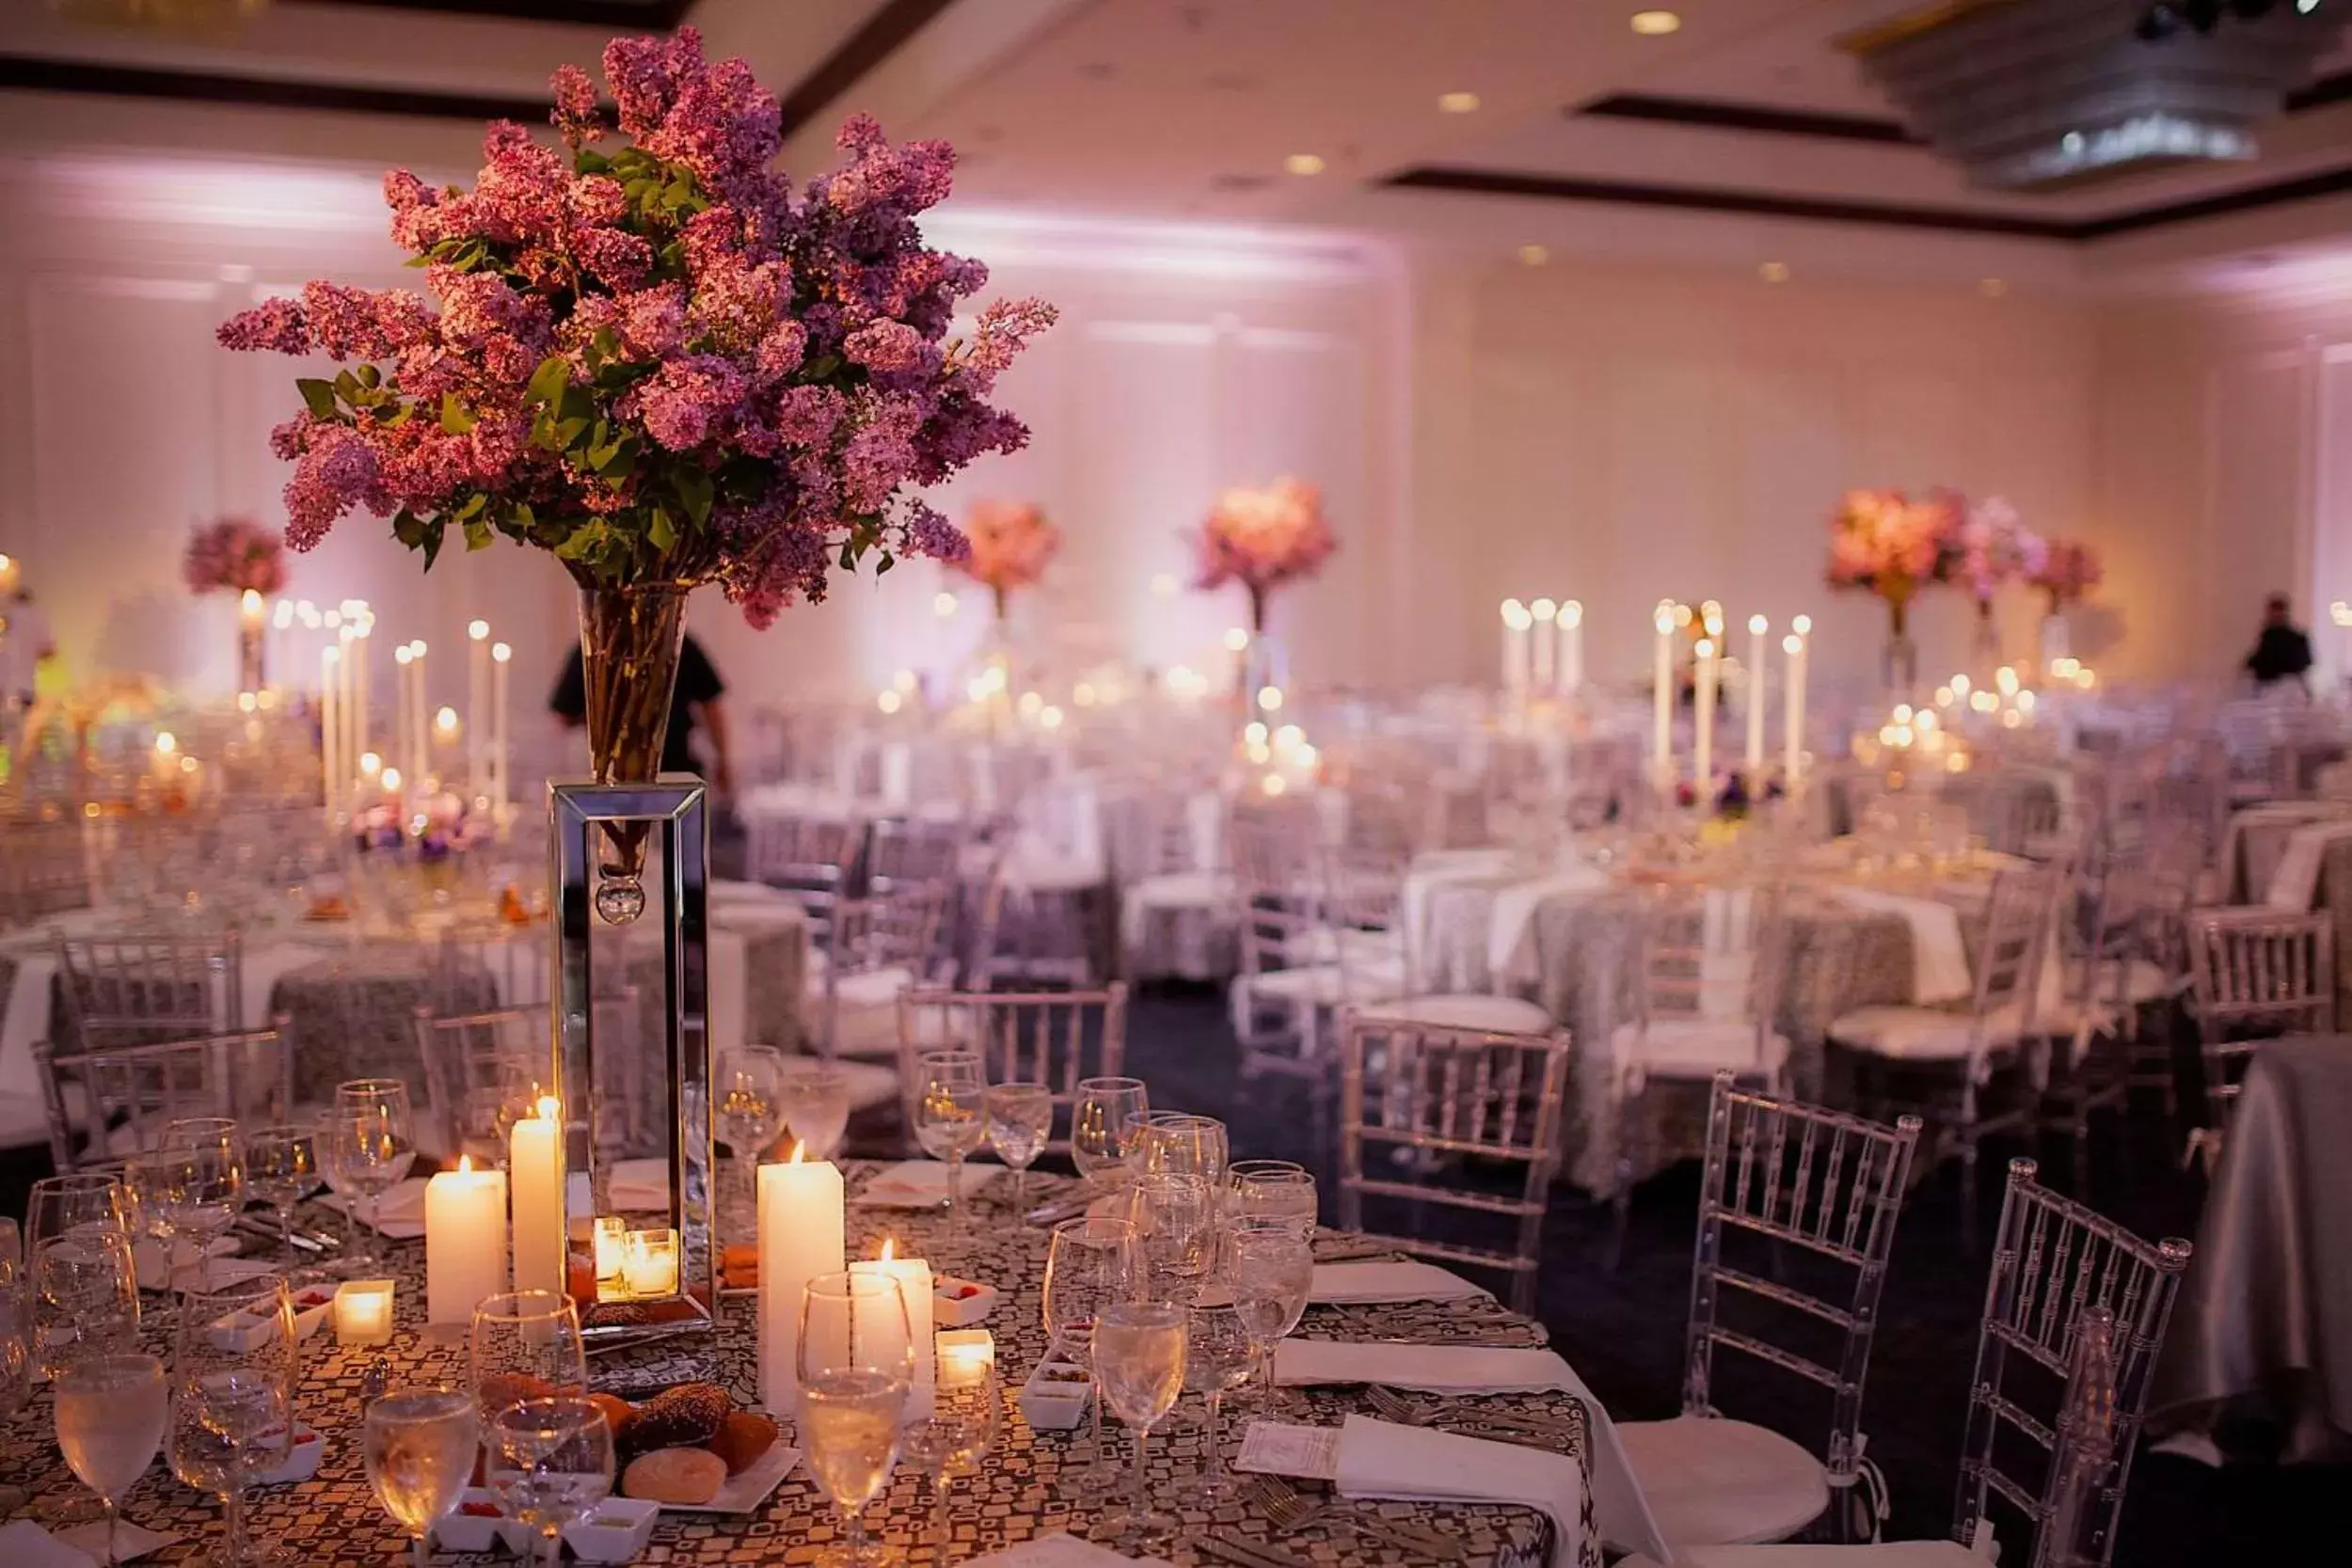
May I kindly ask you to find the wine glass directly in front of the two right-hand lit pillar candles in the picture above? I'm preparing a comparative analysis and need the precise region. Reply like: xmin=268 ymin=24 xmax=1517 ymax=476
xmin=798 ymin=1270 xmax=915 ymax=1568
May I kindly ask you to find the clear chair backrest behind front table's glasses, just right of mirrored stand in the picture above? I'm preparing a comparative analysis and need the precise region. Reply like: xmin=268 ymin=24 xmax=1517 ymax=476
xmin=898 ymin=983 xmax=1127 ymax=1154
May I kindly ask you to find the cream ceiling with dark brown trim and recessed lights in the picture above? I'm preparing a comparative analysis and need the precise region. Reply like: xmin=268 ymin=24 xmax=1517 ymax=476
xmin=0 ymin=0 xmax=2352 ymax=275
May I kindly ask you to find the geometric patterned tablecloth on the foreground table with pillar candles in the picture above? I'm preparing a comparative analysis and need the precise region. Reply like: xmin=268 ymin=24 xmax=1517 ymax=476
xmin=0 ymin=1166 xmax=1599 ymax=1568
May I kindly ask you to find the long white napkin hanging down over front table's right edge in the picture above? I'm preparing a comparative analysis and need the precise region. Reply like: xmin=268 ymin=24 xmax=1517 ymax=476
xmin=1275 ymin=1340 xmax=1673 ymax=1563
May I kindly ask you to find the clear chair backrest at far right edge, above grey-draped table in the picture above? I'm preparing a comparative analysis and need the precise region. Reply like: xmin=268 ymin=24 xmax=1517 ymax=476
xmin=2190 ymin=908 xmax=2336 ymax=1102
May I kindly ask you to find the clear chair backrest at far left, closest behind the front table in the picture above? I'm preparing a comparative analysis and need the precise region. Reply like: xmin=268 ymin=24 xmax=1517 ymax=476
xmin=33 ymin=1030 xmax=294 ymax=1171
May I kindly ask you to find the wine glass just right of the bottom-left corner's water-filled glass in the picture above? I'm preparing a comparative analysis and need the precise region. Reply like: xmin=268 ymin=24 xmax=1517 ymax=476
xmin=172 ymin=1275 xmax=296 ymax=1568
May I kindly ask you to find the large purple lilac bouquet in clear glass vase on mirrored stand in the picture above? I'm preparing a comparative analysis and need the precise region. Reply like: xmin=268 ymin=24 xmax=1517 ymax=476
xmin=219 ymin=28 xmax=1054 ymax=911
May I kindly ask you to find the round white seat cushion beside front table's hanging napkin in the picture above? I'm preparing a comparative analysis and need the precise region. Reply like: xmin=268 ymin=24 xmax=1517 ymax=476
xmin=1616 ymin=1416 xmax=1830 ymax=1561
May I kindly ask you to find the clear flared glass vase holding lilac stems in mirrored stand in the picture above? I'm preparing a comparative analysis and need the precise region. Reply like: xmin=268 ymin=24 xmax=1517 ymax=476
xmin=581 ymin=583 xmax=690 ymax=927
